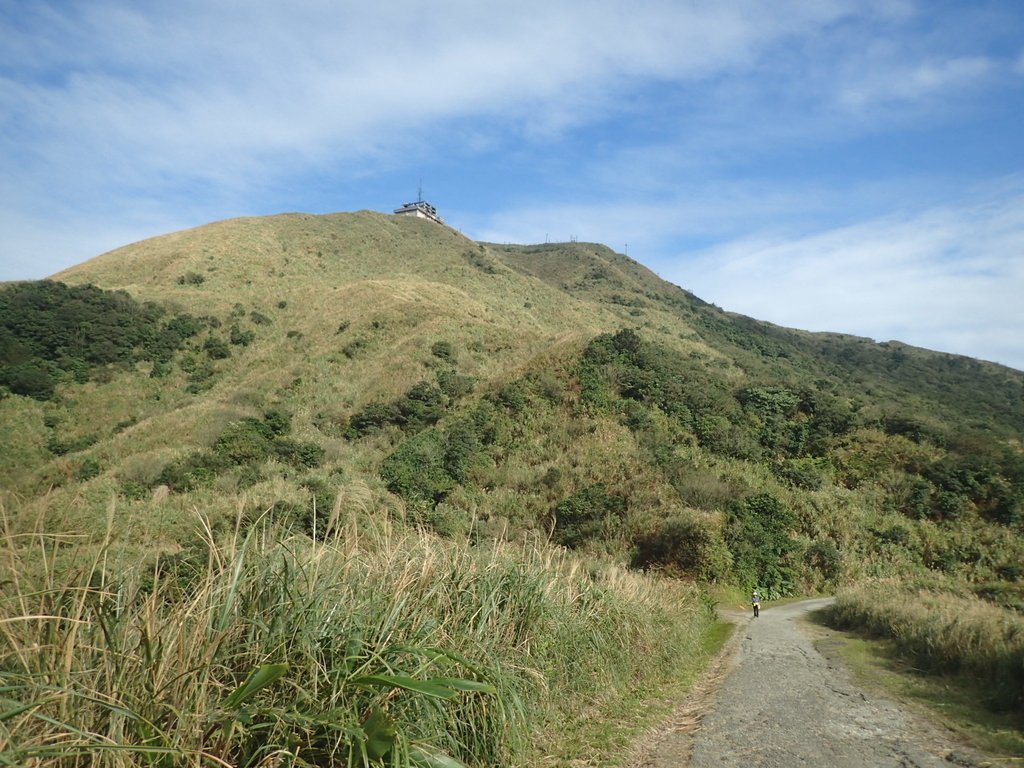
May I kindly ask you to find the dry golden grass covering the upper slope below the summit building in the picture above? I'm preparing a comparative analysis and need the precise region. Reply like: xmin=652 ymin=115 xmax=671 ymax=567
xmin=0 ymin=211 xmax=714 ymax=561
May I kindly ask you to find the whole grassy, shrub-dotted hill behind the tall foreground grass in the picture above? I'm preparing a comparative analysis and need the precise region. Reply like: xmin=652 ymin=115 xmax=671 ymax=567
xmin=0 ymin=211 xmax=1024 ymax=592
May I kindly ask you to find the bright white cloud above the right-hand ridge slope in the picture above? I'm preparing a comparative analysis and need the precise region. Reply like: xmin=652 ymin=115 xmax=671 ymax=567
xmin=667 ymin=184 xmax=1024 ymax=370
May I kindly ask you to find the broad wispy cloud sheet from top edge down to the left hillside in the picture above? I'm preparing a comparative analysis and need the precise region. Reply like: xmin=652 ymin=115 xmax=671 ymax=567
xmin=0 ymin=0 xmax=880 ymax=276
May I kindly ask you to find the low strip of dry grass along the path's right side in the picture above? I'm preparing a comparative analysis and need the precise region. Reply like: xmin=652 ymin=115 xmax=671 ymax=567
xmin=830 ymin=581 xmax=1024 ymax=713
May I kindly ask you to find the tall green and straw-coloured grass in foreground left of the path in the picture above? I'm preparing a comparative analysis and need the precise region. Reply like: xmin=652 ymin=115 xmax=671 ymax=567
xmin=0 ymin=507 xmax=708 ymax=768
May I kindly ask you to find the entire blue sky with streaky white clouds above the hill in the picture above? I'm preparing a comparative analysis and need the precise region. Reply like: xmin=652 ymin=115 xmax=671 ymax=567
xmin=0 ymin=0 xmax=1024 ymax=370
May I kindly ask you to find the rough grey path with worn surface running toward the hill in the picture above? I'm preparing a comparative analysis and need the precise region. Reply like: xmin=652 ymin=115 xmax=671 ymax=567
xmin=633 ymin=599 xmax=985 ymax=768
